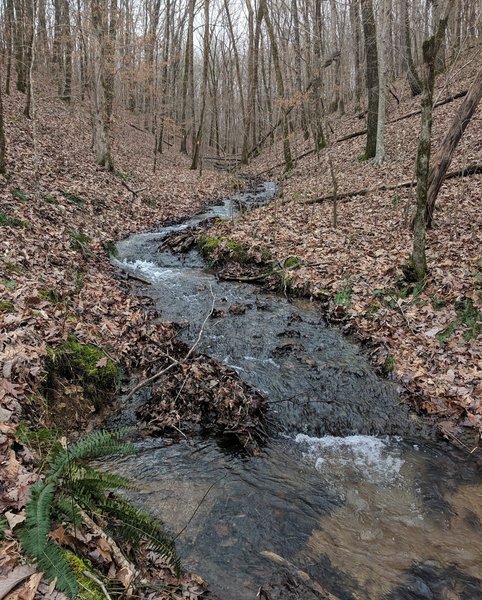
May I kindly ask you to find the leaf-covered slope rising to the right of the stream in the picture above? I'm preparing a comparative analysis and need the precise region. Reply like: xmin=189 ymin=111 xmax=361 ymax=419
xmin=208 ymin=58 xmax=482 ymax=448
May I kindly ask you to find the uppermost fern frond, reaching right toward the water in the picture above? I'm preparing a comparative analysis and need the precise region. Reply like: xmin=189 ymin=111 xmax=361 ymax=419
xmin=47 ymin=431 xmax=136 ymax=481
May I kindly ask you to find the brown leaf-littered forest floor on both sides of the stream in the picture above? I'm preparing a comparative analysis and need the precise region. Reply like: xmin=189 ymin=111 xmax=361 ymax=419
xmin=0 ymin=51 xmax=482 ymax=599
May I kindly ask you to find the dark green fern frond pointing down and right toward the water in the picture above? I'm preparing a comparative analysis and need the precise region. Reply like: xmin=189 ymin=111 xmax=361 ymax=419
xmin=99 ymin=497 xmax=181 ymax=575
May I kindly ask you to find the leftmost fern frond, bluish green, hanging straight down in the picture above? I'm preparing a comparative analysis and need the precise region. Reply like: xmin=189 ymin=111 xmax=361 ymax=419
xmin=19 ymin=481 xmax=55 ymax=560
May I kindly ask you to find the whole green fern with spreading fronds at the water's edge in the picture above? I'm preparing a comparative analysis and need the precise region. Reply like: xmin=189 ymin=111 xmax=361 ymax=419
xmin=19 ymin=431 xmax=180 ymax=597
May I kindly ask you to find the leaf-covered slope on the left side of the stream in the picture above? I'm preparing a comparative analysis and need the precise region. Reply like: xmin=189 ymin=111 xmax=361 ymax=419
xmin=0 ymin=78 xmax=233 ymax=597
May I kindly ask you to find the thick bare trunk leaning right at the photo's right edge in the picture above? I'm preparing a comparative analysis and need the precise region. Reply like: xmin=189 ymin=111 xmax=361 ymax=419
xmin=426 ymin=68 xmax=482 ymax=227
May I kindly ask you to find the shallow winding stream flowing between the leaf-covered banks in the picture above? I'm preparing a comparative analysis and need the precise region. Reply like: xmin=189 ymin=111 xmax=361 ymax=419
xmin=106 ymin=182 xmax=482 ymax=600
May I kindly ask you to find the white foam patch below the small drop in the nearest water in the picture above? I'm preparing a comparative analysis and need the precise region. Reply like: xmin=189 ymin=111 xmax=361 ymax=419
xmin=295 ymin=433 xmax=404 ymax=483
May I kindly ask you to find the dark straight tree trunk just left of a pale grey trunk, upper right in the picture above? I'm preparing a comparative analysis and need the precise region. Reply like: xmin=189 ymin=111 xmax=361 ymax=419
xmin=361 ymin=0 xmax=379 ymax=158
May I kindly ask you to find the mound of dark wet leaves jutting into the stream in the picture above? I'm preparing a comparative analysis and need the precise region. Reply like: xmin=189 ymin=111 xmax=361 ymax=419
xmin=137 ymin=356 xmax=265 ymax=454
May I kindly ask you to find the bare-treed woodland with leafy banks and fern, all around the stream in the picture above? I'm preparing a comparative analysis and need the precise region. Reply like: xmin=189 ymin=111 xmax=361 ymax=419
xmin=0 ymin=0 xmax=482 ymax=600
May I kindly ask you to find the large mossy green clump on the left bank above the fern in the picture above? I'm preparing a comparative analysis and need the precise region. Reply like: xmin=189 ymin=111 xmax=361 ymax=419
xmin=48 ymin=337 xmax=121 ymax=409
